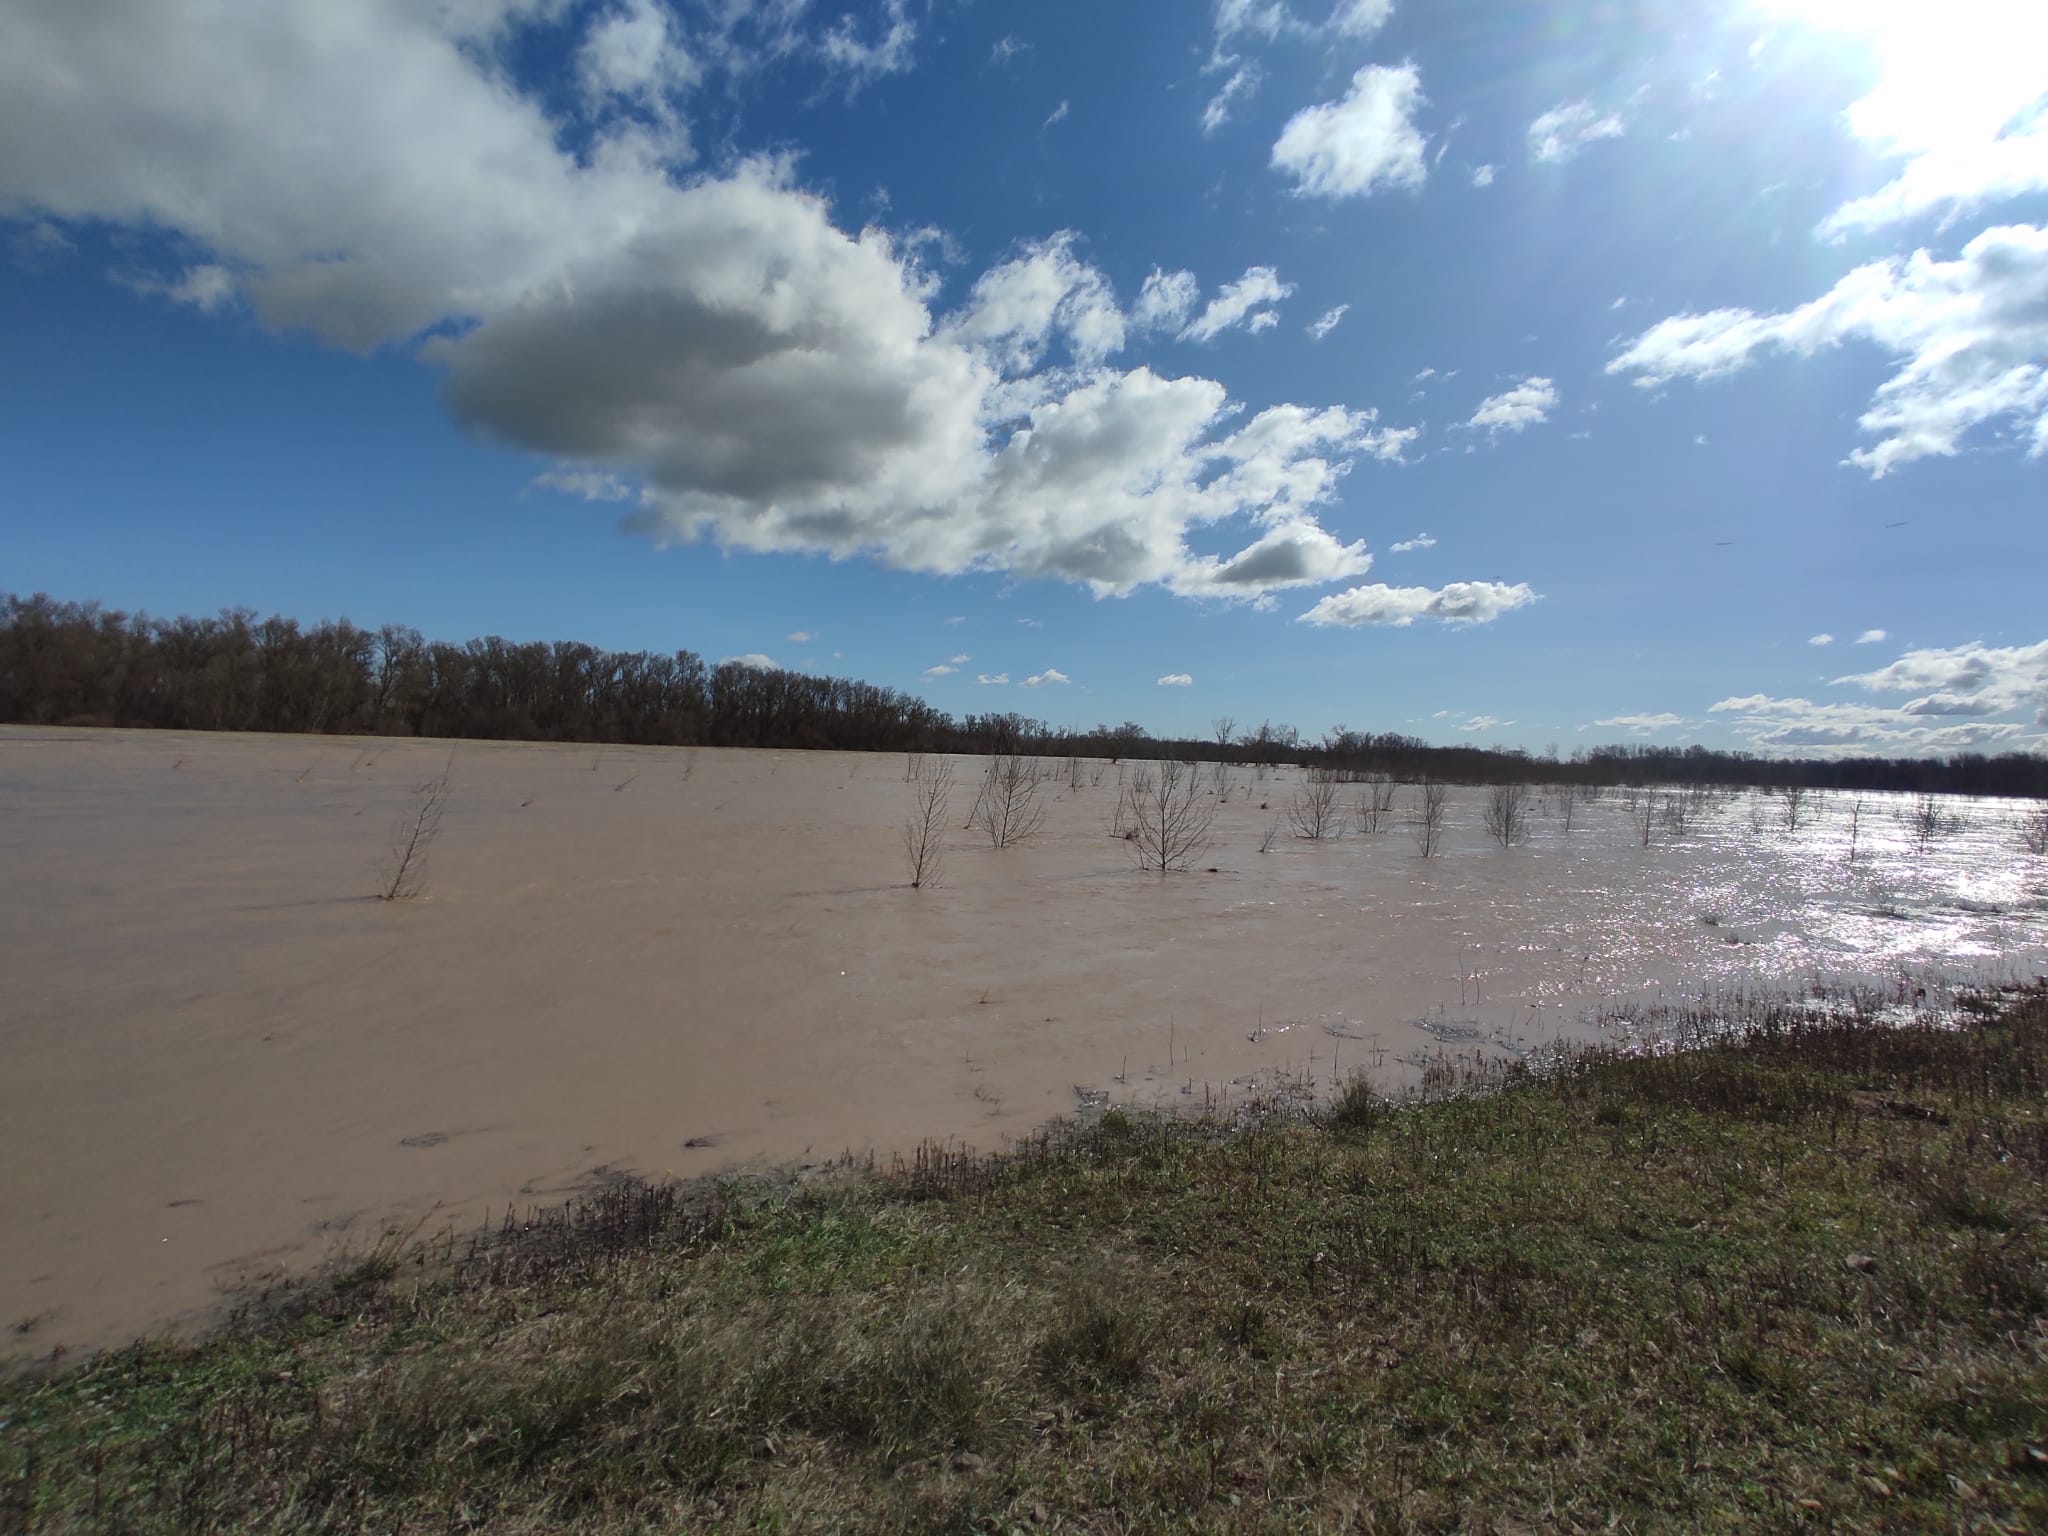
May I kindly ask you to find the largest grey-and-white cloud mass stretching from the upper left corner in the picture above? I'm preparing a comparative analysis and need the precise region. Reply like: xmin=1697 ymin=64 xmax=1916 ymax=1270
xmin=0 ymin=0 xmax=1415 ymax=598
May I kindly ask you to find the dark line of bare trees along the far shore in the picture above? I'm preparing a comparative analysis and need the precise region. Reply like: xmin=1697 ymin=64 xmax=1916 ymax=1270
xmin=0 ymin=594 xmax=2048 ymax=797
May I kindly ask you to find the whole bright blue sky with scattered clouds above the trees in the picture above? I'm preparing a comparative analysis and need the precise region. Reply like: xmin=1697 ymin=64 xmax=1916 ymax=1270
xmin=0 ymin=0 xmax=2048 ymax=754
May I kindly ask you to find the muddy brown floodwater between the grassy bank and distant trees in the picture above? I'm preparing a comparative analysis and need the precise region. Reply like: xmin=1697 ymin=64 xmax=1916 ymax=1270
xmin=0 ymin=729 xmax=2048 ymax=1360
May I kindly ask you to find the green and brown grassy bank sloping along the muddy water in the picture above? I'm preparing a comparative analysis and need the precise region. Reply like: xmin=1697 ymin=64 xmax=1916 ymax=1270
xmin=0 ymin=991 xmax=2048 ymax=1532
